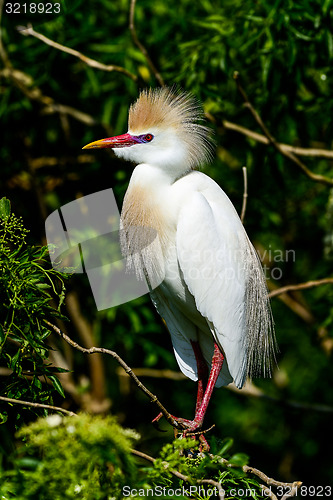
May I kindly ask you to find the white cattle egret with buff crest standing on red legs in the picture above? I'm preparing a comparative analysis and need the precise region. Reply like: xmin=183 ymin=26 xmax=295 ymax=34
xmin=83 ymin=87 xmax=275 ymax=440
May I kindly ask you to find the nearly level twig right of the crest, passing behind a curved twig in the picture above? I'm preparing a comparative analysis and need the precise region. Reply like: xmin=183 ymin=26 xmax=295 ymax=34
xmin=222 ymin=120 xmax=333 ymax=160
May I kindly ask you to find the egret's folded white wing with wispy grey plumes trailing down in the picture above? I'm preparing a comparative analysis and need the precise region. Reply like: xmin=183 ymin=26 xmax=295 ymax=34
xmin=177 ymin=178 xmax=274 ymax=387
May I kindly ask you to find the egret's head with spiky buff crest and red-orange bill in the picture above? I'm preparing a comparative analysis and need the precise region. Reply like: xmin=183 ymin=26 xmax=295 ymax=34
xmin=83 ymin=87 xmax=212 ymax=177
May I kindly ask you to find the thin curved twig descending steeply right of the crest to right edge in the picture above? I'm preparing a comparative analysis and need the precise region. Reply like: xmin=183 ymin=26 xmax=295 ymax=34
xmin=234 ymin=71 xmax=333 ymax=186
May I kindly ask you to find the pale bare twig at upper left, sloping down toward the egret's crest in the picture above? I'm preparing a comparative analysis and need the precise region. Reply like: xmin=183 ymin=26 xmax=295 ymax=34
xmin=18 ymin=24 xmax=138 ymax=82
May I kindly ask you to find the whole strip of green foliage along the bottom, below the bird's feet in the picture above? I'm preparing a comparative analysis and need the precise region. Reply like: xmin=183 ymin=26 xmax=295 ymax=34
xmin=0 ymin=414 xmax=264 ymax=500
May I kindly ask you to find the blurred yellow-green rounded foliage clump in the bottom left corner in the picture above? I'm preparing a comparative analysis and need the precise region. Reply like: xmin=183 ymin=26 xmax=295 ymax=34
xmin=0 ymin=414 xmax=138 ymax=500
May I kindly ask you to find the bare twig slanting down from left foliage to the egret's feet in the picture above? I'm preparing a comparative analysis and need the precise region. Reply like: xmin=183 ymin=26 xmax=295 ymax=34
xmin=44 ymin=320 xmax=182 ymax=429
